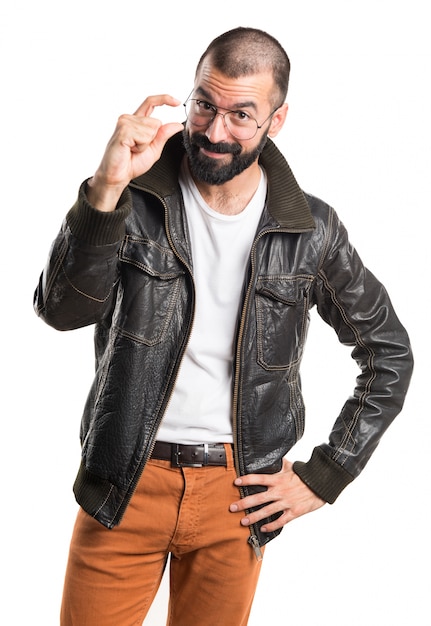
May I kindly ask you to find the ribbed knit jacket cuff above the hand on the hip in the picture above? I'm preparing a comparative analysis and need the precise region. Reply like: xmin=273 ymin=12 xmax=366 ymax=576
xmin=292 ymin=447 xmax=354 ymax=504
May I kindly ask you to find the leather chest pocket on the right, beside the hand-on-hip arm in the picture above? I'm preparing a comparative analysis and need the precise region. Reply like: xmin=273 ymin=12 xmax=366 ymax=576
xmin=256 ymin=276 xmax=313 ymax=370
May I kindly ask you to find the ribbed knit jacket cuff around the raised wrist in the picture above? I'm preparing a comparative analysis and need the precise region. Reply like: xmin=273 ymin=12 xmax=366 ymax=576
xmin=66 ymin=181 xmax=132 ymax=246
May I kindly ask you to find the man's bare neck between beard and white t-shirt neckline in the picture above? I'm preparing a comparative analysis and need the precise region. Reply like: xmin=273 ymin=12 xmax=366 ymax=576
xmin=193 ymin=161 xmax=260 ymax=215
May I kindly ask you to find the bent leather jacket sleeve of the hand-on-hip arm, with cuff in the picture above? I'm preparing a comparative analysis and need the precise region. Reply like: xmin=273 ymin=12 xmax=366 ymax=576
xmin=293 ymin=211 xmax=413 ymax=503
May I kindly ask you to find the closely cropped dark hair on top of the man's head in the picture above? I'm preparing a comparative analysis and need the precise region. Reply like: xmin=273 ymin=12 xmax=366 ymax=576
xmin=196 ymin=26 xmax=290 ymax=105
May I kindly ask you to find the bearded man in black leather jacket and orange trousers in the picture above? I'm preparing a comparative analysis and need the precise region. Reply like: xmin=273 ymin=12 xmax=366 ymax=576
xmin=35 ymin=28 xmax=412 ymax=626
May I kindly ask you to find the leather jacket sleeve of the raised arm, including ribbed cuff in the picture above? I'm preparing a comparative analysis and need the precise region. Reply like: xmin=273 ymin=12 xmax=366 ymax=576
xmin=34 ymin=182 xmax=132 ymax=330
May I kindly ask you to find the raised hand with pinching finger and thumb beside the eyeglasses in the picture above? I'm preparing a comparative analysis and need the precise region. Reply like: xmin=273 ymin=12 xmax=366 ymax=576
xmin=87 ymin=94 xmax=183 ymax=211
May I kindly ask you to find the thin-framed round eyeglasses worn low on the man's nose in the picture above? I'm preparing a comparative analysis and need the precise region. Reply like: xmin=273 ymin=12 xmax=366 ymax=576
xmin=184 ymin=98 xmax=280 ymax=141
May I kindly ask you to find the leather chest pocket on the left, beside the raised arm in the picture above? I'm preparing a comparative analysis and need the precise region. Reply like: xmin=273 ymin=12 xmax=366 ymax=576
xmin=114 ymin=235 xmax=185 ymax=346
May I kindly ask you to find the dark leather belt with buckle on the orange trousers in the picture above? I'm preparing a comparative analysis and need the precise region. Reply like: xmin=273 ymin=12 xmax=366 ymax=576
xmin=151 ymin=441 xmax=226 ymax=467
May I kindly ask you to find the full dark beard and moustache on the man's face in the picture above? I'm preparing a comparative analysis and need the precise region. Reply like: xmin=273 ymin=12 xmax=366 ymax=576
xmin=183 ymin=128 xmax=268 ymax=185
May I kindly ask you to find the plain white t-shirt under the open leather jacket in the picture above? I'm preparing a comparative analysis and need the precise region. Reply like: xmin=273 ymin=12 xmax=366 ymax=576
xmin=157 ymin=160 xmax=267 ymax=444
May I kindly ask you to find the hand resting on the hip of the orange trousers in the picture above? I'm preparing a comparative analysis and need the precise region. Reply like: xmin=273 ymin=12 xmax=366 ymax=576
xmin=229 ymin=459 xmax=325 ymax=533
